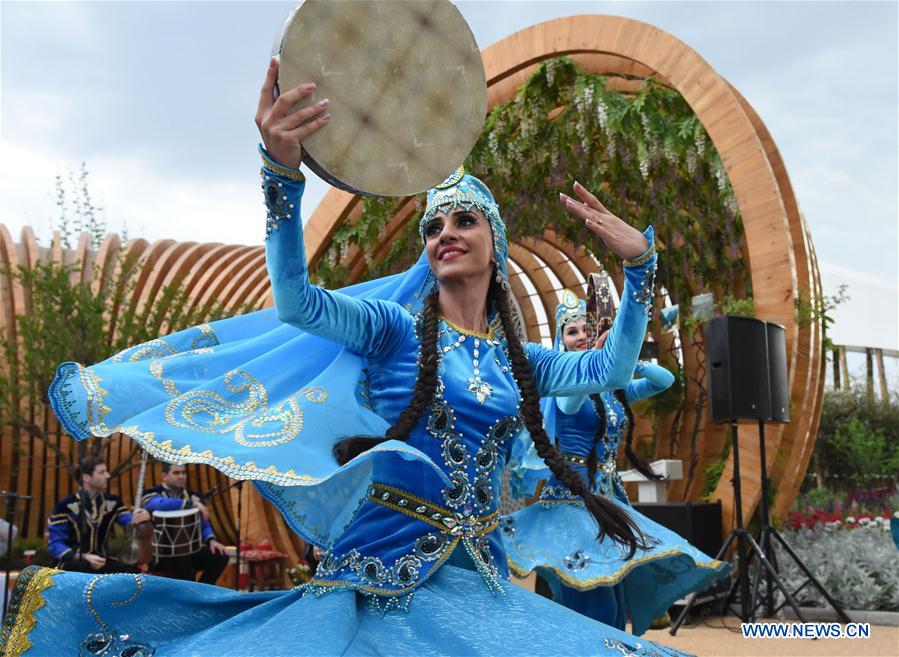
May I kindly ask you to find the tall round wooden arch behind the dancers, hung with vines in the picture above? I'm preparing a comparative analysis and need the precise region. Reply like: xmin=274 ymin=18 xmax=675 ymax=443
xmin=298 ymin=15 xmax=824 ymax=528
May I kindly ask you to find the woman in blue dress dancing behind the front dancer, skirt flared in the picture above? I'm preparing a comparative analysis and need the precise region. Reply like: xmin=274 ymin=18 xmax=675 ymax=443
xmin=501 ymin=290 xmax=729 ymax=635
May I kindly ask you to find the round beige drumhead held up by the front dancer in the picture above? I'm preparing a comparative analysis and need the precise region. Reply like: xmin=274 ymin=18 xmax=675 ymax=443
xmin=278 ymin=0 xmax=487 ymax=196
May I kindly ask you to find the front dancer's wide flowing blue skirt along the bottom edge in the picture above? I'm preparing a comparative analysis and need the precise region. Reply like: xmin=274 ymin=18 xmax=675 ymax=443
xmin=0 ymin=565 xmax=683 ymax=657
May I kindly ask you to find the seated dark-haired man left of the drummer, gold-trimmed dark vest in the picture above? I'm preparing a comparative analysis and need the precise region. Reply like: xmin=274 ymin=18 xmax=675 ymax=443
xmin=48 ymin=457 xmax=150 ymax=573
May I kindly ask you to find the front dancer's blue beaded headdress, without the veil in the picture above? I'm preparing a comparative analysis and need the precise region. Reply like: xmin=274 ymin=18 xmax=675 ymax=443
xmin=418 ymin=166 xmax=509 ymax=280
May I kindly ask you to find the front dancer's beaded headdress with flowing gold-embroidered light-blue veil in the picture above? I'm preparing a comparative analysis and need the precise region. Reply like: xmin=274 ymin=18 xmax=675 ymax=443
xmin=49 ymin=168 xmax=508 ymax=546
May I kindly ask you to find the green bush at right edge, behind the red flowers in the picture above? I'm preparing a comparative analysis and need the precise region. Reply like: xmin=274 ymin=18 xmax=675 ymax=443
xmin=804 ymin=389 xmax=899 ymax=491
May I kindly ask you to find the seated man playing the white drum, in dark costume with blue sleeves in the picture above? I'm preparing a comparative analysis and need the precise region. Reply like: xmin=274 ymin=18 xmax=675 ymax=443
xmin=141 ymin=463 xmax=228 ymax=584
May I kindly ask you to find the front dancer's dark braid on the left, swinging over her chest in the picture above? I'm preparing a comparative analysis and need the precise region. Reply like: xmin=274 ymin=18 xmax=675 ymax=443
xmin=334 ymin=290 xmax=440 ymax=465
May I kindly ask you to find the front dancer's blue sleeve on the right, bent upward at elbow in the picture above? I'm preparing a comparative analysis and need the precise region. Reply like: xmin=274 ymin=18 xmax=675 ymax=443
xmin=525 ymin=226 xmax=656 ymax=397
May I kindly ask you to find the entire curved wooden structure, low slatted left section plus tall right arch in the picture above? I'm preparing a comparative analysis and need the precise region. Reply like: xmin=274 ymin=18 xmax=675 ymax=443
xmin=0 ymin=15 xmax=824 ymax=555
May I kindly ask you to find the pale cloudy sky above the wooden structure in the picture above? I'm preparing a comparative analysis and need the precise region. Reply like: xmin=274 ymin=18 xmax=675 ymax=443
xmin=0 ymin=0 xmax=899 ymax=368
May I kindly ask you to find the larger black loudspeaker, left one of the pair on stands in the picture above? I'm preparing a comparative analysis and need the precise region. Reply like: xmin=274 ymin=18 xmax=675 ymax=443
xmin=705 ymin=315 xmax=771 ymax=422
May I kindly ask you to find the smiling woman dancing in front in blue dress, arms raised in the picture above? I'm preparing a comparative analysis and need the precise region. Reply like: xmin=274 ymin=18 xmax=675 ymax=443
xmin=3 ymin=62 xmax=688 ymax=657
